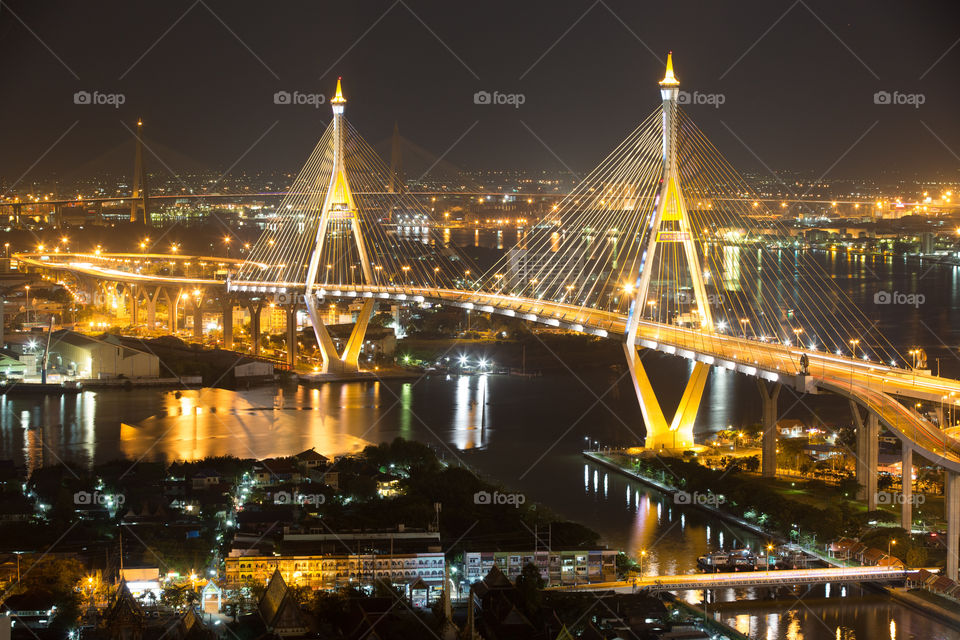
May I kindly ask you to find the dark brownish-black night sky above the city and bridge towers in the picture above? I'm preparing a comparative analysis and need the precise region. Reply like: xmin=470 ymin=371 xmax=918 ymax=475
xmin=0 ymin=0 xmax=960 ymax=186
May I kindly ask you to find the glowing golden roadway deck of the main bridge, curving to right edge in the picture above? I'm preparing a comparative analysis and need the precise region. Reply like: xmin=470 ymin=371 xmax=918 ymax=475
xmin=16 ymin=254 xmax=960 ymax=472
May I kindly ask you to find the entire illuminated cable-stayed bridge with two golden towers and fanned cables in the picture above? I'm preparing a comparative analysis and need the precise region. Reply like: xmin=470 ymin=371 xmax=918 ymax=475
xmin=23 ymin=57 xmax=960 ymax=578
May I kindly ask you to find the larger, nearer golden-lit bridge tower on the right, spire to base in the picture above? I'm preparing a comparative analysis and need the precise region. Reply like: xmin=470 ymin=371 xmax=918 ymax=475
xmin=624 ymin=52 xmax=713 ymax=450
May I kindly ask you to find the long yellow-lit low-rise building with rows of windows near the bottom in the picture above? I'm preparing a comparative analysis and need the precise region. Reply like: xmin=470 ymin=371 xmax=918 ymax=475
xmin=224 ymin=551 xmax=446 ymax=599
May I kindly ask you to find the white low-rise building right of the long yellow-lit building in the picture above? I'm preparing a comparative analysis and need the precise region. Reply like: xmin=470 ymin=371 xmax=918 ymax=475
xmin=463 ymin=549 xmax=617 ymax=586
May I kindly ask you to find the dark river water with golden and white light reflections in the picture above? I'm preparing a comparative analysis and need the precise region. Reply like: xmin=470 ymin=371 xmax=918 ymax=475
xmin=0 ymin=256 xmax=960 ymax=640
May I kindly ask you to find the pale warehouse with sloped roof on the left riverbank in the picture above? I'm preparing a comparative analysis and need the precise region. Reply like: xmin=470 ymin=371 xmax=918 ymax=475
xmin=49 ymin=329 xmax=160 ymax=380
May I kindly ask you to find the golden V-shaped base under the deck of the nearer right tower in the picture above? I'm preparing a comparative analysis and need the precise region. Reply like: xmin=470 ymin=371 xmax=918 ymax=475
xmin=623 ymin=342 xmax=710 ymax=450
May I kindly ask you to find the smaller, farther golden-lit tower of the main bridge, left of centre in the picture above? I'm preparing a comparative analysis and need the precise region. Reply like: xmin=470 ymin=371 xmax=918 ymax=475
xmin=304 ymin=78 xmax=374 ymax=373
